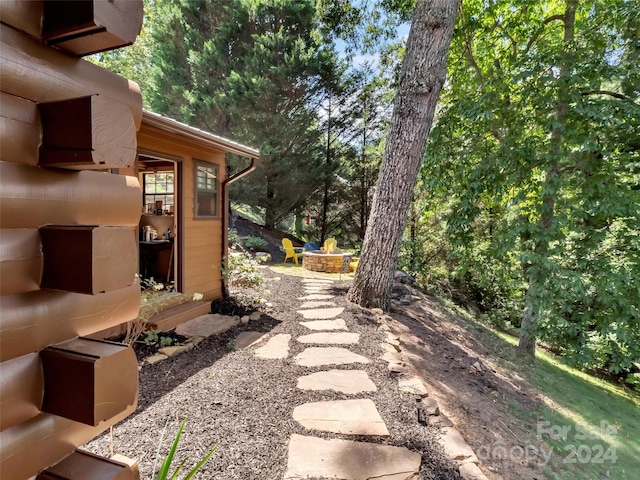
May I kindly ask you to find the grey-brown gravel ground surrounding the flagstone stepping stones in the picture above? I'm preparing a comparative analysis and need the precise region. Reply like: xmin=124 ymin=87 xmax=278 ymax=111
xmin=83 ymin=267 xmax=459 ymax=480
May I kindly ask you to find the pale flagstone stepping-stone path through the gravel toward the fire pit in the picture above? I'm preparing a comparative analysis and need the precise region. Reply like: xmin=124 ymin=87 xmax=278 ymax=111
xmin=256 ymin=278 xmax=421 ymax=480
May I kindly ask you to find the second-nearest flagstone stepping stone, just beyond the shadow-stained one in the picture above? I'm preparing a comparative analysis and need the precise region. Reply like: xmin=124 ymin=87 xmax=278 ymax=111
xmin=293 ymin=398 xmax=389 ymax=437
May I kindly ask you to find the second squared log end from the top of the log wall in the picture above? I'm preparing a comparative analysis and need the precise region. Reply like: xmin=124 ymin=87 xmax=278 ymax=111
xmin=38 ymin=95 xmax=137 ymax=170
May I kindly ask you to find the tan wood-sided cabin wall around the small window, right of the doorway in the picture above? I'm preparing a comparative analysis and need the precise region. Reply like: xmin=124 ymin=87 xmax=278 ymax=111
xmin=138 ymin=120 xmax=226 ymax=300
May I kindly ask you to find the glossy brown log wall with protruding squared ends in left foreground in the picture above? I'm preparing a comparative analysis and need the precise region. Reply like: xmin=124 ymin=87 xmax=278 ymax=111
xmin=0 ymin=0 xmax=143 ymax=480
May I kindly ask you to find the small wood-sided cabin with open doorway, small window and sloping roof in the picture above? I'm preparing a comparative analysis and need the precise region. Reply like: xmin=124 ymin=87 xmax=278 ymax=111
xmin=130 ymin=111 xmax=259 ymax=330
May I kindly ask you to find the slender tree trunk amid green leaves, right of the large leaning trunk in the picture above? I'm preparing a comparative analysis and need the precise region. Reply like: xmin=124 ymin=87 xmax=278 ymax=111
xmin=518 ymin=0 xmax=578 ymax=357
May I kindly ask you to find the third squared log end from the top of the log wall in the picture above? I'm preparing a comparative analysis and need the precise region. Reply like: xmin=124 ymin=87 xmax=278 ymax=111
xmin=40 ymin=225 xmax=138 ymax=295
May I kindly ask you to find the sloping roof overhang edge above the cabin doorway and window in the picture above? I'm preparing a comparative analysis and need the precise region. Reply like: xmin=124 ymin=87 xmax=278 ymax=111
xmin=142 ymin=110 xmax=260 ymax=159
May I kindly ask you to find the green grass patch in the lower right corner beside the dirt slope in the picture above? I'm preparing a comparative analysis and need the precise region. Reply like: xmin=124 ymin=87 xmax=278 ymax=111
xmin=485 ymin=331 xmax=640 ymax=480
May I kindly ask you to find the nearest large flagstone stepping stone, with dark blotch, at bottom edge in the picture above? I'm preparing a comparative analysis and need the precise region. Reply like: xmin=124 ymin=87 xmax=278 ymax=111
xmin=284 ymin=434 xmax=421 ymax=480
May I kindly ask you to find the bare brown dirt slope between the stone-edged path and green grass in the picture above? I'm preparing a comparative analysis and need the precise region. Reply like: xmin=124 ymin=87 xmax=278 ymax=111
xmin=390 ymin=287 xmax=544 ymax=480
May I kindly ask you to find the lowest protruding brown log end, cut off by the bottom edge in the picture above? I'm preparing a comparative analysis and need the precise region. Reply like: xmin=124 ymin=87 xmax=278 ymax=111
xmin=36 ymin=450 xmax=139 ymax=480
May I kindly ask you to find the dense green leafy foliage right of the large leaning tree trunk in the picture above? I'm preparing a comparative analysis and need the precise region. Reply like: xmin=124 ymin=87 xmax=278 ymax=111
xmin=410 ymin=0 xmax=640 ymax=376
